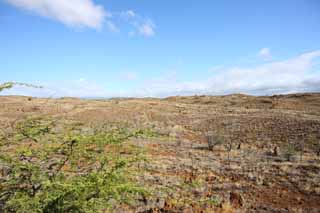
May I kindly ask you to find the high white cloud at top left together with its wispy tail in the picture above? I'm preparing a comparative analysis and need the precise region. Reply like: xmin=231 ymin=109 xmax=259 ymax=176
xmin=4 ymin=0 xmax=156 ymax=37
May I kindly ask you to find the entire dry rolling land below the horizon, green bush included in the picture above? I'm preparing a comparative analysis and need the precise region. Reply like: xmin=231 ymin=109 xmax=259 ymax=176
xmin=0 ymin=93 xmax=320 ymax=212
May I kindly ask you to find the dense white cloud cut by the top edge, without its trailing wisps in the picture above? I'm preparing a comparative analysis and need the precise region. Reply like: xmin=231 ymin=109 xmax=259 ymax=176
xmin=5 ymin=0 xmax=111 ymax=29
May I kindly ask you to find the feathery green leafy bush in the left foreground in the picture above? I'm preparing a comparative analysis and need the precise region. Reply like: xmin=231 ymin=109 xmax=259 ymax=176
xmin=0 ymin=118 xmax=149 ymax=212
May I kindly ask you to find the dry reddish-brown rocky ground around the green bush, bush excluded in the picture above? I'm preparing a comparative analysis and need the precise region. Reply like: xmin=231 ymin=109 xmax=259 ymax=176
xmin=0 ymin=93 xmax=320 ymax=212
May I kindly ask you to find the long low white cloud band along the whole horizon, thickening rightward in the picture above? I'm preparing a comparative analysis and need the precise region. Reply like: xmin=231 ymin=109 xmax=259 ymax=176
xmin=1 ymin=50 xmax=320 ymax=97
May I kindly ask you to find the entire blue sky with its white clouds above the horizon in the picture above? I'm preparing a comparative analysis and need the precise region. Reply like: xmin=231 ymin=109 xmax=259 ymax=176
xmin=0 ymin=0 xmax=320 ymax=97
